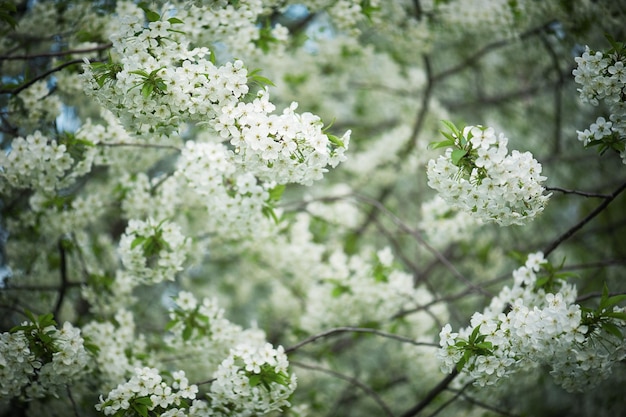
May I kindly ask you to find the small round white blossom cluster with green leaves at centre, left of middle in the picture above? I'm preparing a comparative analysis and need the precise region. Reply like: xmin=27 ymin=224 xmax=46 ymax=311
xmin=119 ymin=218 xmax=187 ymax=284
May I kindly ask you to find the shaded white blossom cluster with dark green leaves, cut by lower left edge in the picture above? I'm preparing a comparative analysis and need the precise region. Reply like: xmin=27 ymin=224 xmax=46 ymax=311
xmin=0 ymin=314 xmax=90 ymax=400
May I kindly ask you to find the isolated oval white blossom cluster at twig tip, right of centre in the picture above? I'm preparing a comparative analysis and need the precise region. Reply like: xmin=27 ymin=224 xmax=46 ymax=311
xmin=427 ymin=124 xmax=549 ymax=226
